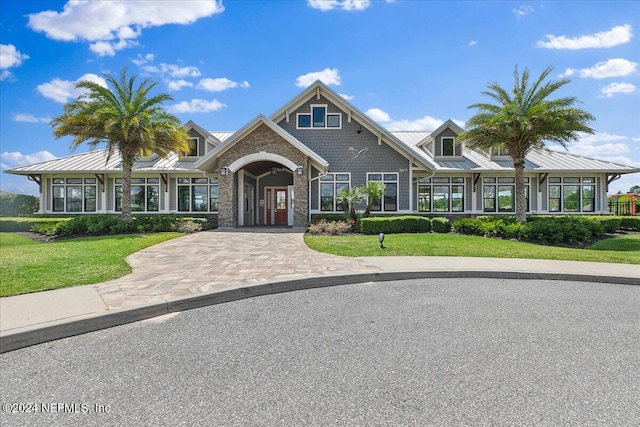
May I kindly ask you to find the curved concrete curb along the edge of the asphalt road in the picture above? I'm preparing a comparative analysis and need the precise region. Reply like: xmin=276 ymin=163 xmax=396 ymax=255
xmin=0 ymin=271 xmax=640 ymax=353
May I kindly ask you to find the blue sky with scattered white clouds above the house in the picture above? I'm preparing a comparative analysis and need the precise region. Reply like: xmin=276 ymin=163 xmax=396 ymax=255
xmin=0 ymin=0 xmax=640 ymax=194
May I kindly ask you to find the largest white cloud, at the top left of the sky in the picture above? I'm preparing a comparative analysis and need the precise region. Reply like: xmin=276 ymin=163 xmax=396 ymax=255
xmin=27 ymin=0 xmax=224 ymax=56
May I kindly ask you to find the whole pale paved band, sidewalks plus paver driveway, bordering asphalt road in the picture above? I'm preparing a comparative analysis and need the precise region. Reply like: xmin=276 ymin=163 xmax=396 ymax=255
xmin=0 ymin=229 xmax=640 ymax=352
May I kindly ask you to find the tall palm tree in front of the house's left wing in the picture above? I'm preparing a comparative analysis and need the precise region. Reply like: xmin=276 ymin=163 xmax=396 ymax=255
xmin=51 ymin=67 xmax=190 ymax=221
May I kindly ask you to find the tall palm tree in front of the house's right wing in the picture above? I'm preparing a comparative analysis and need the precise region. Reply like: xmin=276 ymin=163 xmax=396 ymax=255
xmin=458 ymin=66 xmax=595 ymax=222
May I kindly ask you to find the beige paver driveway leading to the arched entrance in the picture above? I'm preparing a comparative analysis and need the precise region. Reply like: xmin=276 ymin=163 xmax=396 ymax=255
xmin=96 ymin=228 xmax=381 ymax=309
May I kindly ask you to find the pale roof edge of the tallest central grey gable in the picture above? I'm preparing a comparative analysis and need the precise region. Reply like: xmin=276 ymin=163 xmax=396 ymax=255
xmin=270 ymin=80 xmax=433 ymax=169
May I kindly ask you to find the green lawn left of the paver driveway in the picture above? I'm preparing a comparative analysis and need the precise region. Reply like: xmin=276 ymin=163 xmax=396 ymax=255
xmin=0 ymin=233 xmax=182 ymax=297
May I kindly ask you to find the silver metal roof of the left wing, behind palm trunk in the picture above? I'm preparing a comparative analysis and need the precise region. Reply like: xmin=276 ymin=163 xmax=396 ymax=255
xmin=5 ymin=148 xmax=199 ymax=175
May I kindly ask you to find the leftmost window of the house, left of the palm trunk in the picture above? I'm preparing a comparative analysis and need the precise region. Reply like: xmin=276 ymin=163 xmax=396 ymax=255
xmin=52 ymin=178 xmax=98 ymax=212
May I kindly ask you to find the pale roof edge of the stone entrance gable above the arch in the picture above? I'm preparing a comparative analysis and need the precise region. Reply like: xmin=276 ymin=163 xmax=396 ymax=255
xmin=195 ymin=114 xmax=329 ymax=174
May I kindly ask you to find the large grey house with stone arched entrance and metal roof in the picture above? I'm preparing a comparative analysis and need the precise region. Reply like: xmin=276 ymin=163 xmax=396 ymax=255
xmin=5 ymin=82 xmax=640 ymax=227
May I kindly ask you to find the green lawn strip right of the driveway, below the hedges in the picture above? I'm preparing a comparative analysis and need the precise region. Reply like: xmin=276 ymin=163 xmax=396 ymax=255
xmin=304 ymin=233 xmax=640 ymax=264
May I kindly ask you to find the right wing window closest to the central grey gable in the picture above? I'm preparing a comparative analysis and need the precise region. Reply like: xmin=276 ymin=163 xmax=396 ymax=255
xmin=418 ymin=177 xmax=464 ymax=212
